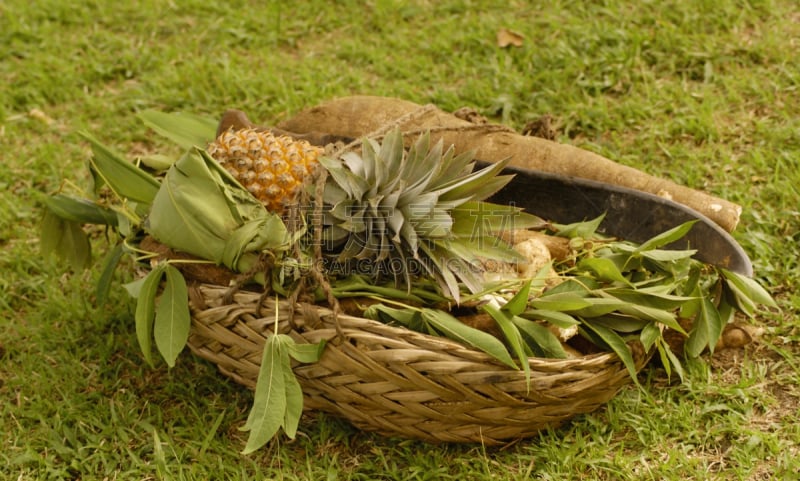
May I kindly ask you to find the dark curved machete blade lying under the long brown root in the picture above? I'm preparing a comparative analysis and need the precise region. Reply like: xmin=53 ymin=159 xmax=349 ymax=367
xmin=484 ymin=162 xmax=753 ymax=277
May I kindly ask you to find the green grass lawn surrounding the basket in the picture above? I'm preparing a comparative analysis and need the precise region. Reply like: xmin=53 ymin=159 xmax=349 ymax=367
xmin=0 ymin=0 xmax=800 ymax=480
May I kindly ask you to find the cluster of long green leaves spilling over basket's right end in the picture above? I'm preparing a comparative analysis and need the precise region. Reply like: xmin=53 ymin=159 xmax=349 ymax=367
xmin=522 ymin=219 xmax=775 ymax=376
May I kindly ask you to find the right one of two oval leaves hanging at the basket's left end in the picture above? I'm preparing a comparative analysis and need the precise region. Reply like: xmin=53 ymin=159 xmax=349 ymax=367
xmin=153 ymin=264 xmax=192 ymax=367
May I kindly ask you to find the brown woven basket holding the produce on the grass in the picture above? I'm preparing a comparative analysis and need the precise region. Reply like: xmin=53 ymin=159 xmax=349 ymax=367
xmin=189 ymin=284 xmax=652 ymax=445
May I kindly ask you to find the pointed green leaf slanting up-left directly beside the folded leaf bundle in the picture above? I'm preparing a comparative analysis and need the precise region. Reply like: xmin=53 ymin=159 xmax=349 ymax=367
xmin=81 ymin=132 xmax=159 ymax=205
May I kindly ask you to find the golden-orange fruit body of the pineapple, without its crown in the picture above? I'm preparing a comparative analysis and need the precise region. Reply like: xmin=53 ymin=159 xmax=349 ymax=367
xmin=208 ymin=128 xmax=323 ymax=213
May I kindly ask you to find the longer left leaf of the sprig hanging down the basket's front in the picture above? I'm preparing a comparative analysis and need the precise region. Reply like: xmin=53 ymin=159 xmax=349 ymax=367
xmin=243 ymin=335 xmax=289 ymax=454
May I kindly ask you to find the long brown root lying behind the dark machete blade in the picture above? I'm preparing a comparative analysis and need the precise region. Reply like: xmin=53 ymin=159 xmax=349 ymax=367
xmin=278 ymin=96 xmax=741 ymax=232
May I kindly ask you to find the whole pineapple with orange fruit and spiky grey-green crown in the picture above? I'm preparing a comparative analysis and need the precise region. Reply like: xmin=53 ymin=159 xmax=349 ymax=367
xmin=208 ymin=121 xmax=529 ymax=301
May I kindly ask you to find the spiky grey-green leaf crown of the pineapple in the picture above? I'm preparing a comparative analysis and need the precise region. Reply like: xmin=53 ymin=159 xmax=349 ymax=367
xmin=320 ymin=130 xmax=538 ymax=300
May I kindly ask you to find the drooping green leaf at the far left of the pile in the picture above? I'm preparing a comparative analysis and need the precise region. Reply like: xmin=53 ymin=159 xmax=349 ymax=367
xmin=40 ymin=209 xmax=92 ymax=271
